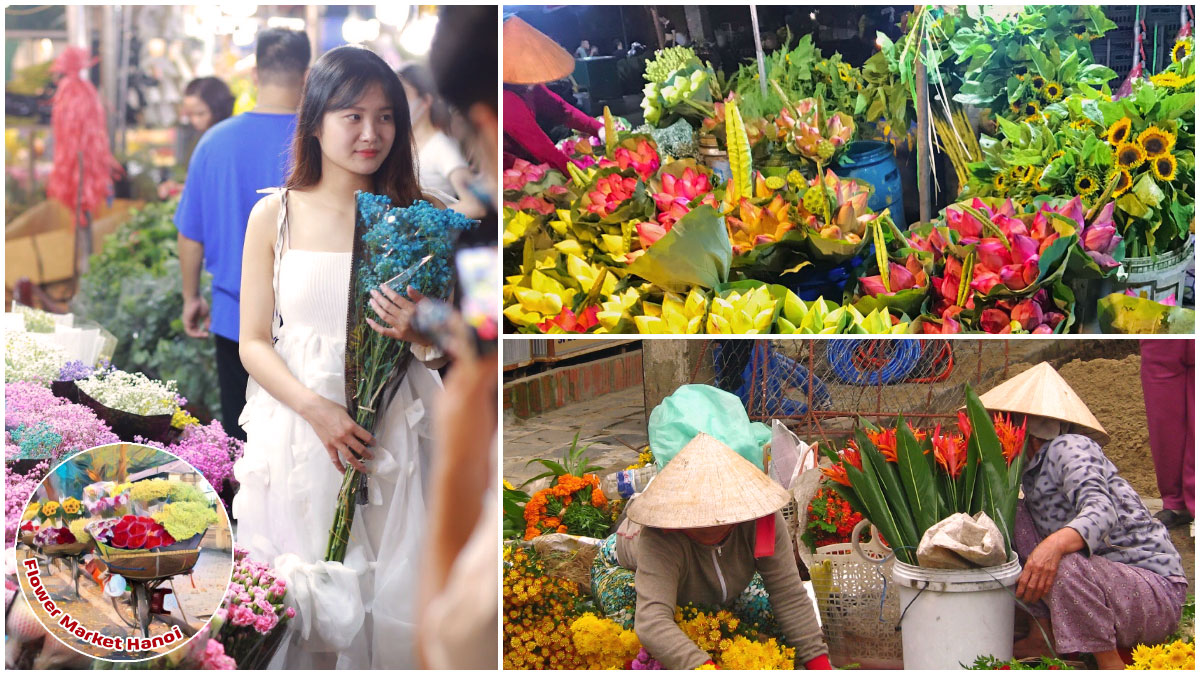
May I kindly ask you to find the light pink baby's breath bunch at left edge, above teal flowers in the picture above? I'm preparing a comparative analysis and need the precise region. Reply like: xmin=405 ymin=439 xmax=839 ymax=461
xmin=4 ymin=382 xmax=120 ymax=456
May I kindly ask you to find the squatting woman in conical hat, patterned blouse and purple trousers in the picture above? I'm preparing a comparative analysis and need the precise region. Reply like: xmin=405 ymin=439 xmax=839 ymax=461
xmin=980 ymin=363 xmax=1188 ymax=669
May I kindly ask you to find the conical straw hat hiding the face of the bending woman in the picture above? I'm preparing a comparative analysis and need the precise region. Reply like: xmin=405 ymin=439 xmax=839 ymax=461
xmin=629 ymin=434 xmax=791 ymax=530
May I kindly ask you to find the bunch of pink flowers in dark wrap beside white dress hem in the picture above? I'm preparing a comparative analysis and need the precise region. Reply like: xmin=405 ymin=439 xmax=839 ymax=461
xmin=205 ymin=548 xmax=296 ymax=669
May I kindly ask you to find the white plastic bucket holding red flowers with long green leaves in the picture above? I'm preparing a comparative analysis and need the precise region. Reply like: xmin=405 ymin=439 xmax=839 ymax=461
xmin=892 ymin=555 xmax=1021 ymax=670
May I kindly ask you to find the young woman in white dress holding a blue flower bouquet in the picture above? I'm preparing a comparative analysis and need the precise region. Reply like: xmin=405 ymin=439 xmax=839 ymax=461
xmin=233 ymin=47 xmax=444 ymax=669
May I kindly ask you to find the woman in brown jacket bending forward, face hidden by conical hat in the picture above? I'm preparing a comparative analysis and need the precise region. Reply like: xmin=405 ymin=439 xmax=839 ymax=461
xmin=593 ymin=434 xmax=830 ymax=670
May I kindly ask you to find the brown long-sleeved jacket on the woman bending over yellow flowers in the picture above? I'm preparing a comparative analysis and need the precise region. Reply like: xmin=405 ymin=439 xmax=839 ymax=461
xmin=617 ymin=513 xmax=827 ymax=670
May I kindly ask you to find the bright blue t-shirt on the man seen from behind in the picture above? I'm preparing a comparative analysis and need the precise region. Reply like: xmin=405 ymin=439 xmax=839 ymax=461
xmin=175 ymin=112 xmax=296 ymax=340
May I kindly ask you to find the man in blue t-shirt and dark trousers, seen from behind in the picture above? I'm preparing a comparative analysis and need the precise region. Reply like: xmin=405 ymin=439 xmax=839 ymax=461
xmin=175 ymin=29 xmax=312 ymax=440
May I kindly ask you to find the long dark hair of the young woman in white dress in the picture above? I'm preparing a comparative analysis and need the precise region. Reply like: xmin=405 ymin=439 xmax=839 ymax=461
xmin=287 ymin=46 xmax=421 ymax=207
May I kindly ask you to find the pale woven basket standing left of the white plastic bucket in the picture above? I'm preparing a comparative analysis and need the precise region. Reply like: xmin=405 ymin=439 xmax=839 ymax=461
xmin=809 ymin=520 xmax=904 ymax=669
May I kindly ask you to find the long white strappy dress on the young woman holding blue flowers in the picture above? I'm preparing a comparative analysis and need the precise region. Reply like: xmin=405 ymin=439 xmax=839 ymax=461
xmin=233 ymin=192 xmax=442 ymax=669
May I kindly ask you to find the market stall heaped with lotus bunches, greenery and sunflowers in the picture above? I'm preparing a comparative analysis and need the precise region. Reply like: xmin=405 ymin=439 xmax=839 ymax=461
xmin=504 ymin=6 xmax=1195 ymax=334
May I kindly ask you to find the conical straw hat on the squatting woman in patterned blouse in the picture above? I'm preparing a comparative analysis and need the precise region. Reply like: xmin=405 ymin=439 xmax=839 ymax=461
xmin=979 ymin=362 xmax=1109 ymax=446
